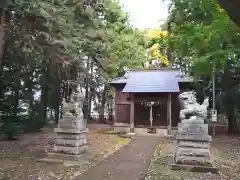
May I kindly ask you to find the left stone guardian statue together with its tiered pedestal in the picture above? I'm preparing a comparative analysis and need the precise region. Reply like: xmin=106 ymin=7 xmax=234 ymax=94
xmin=38 ymin=87 xmax=91 ymax=165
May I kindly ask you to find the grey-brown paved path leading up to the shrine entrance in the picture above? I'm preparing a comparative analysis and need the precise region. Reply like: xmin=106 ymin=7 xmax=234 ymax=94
xmin=74 ymin=137 xmax=161 ymax=180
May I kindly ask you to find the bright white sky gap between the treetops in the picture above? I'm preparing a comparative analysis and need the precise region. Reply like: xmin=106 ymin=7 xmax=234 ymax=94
xmin=119 ymin=0 xmax=168 ymax=29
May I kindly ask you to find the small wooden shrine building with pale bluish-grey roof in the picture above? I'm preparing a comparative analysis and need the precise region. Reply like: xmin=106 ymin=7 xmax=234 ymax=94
xmin=109 ymin=68 xmax=193 ymax=135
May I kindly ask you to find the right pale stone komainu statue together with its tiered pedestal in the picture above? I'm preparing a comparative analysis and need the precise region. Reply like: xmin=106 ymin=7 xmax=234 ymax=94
xmin=172 ymin=91 xmax=218 ymax=173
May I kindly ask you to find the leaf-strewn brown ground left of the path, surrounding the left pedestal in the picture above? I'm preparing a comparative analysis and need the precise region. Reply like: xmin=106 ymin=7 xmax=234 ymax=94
xmin=0 ymin=125 xmax=130 ymax=180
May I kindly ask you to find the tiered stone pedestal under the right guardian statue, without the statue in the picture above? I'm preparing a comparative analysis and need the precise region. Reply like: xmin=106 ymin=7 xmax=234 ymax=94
xmin=172 ymin=121 xmax=217 ymax=173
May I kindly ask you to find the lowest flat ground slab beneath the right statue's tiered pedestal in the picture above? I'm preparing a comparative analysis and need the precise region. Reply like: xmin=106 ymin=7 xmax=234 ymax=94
xmin=171 ymin=164 xmax=218 ymax=174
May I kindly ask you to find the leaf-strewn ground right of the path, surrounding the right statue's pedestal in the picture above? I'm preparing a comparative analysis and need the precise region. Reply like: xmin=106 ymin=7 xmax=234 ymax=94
xmin=145 ymin=136 xmax=240 ymax=180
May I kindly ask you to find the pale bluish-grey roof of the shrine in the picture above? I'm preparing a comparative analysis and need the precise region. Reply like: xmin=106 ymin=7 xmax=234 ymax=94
xmin=109 ymin=69 xmax=193 ymax=92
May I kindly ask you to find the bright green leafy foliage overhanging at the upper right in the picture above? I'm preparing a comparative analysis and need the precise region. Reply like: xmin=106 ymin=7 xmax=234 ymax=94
xmin=169 ymin=0 xmax=240 ymax=76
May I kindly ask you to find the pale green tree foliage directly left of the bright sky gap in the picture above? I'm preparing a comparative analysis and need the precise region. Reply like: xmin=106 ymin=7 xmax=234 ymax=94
xmin=105 ymin=0 xmax=145 ymax=77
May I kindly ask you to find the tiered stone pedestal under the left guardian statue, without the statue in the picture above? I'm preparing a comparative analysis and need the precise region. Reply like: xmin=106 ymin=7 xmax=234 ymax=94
xmin=40 ymin=113 xmax=88 ymax=166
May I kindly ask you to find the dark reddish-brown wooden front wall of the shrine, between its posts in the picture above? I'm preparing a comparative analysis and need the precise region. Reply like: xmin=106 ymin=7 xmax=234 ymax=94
xmin=115 ymin=85 xmax=180 ymax=126
